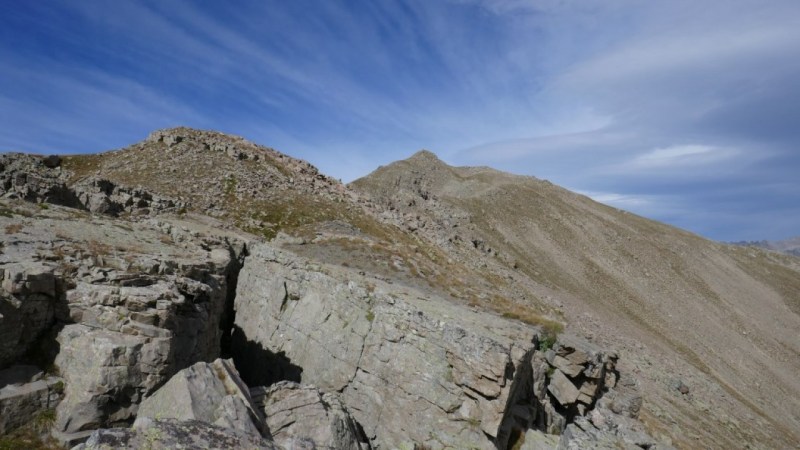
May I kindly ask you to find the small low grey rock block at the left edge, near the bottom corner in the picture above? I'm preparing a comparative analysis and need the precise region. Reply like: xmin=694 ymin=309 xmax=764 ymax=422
xmin=0 ymin=366 xmax=64 ymax=436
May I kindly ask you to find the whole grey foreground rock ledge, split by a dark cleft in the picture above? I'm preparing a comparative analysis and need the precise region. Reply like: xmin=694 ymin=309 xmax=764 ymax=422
xmin=0 ymin=150 xmax=663 ymax=450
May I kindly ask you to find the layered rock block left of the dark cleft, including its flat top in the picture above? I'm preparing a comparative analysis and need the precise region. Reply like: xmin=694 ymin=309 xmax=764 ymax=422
xmin=0 ymin=199 xmax=245 ymax=442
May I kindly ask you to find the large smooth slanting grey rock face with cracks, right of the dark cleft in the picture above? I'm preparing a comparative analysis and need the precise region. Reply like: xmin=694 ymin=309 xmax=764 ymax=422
xmin=235 ymin=245 xmax=536 ymax=448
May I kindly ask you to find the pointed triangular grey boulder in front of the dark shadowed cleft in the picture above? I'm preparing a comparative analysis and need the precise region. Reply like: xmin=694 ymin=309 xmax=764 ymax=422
xmin=135 ymin=359 xmax=269 ymax=436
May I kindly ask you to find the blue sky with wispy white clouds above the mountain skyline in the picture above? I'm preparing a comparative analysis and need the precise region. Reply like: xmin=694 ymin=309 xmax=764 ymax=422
xmin=0 ymin=0 xmax=800 ymax=240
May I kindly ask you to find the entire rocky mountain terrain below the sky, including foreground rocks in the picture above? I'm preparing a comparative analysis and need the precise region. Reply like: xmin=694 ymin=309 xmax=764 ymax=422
xmin=0 ymin=128 xmax=800 ymax=450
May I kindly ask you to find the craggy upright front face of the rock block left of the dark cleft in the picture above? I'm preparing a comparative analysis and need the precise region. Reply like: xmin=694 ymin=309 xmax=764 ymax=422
xmin=55 ymin=251 xmax=238 ymax=442
